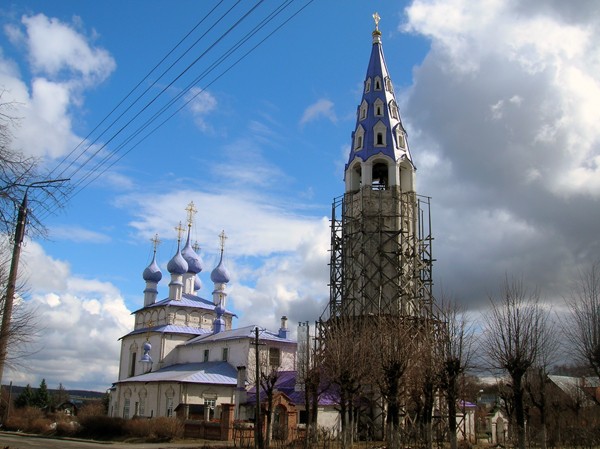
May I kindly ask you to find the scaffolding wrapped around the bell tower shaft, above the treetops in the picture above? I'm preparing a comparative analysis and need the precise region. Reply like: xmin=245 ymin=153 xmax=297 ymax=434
xmin=324 ymin=186 xmax=433 ymax=318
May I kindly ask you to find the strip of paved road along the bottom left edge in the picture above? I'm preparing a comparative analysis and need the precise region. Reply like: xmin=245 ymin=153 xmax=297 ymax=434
xmin=0 ymin=432 xmax=234 ymax=449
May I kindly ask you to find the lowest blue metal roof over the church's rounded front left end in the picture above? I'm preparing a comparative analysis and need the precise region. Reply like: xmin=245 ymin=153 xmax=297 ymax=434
xmin=117 ymin=362 xmax=237 ymax=386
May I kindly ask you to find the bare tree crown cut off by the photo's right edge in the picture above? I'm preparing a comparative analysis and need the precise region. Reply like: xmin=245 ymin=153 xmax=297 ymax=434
xmin=564 ymin=262 xmax=600 ymax=379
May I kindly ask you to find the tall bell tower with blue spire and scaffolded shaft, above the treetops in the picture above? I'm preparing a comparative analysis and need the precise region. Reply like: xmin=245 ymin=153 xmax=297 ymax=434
xmin=329 ymin=13 xmax=433 ymax=317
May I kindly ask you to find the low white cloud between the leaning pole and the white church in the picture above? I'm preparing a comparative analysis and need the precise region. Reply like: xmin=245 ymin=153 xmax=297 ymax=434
xmin=5 ymin=242 xmax=133 ymax=391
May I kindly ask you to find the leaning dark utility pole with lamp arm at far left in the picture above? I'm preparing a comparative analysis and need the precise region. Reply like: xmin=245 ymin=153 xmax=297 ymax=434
xmin=0 ymin=179 xmax=68 ymax=391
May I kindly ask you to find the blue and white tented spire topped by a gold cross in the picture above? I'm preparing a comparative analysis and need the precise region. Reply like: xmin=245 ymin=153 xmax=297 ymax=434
xmin=346 ymin=14 xmax=412 ymax=172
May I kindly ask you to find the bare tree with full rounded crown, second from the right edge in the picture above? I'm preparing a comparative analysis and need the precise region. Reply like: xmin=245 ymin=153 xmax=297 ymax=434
xmin=482 ymin=276 xmax=549 ymax=449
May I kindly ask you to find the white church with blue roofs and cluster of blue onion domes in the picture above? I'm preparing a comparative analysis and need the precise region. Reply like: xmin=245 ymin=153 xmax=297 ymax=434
xmin=109 ymin=210 xmax=296 ymax=420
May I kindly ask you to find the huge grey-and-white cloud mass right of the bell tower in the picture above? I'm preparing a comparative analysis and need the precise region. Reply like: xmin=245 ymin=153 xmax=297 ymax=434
xmin=400 ymin=0 xmax=600 ymax=305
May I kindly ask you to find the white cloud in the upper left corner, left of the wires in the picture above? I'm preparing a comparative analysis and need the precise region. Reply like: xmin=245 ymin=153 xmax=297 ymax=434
xmin=0 ymin=14 xmax=115 ymax=158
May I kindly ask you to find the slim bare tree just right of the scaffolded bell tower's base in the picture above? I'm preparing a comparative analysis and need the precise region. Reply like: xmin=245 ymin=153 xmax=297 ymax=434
xmin=438 ymin=298 xmax=473 ymax=449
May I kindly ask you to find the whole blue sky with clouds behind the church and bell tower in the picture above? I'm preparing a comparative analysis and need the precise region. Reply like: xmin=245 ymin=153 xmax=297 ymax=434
xmin=0 ymin=0 xmax=600 ymax=391
